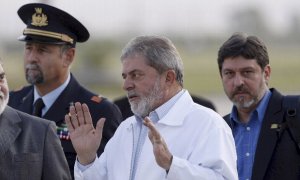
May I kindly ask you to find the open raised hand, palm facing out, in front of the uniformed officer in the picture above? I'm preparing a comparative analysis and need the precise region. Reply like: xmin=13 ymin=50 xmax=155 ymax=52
xmin=65 ymin=102 xmax=105 ymax=165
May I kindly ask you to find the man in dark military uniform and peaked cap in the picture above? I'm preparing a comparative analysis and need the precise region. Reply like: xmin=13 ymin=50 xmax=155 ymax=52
xmin=9 ymin=3 xmax=122 ymax=179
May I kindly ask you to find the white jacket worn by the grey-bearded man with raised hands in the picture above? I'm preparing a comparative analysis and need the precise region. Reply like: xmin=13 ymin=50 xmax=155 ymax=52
xmin=74 ymin=90 xmax=238 ymax=180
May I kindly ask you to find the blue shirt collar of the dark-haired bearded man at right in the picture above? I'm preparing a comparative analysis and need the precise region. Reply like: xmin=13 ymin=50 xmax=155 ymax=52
xmin=230 ymin=90 xmax=272 ymax=123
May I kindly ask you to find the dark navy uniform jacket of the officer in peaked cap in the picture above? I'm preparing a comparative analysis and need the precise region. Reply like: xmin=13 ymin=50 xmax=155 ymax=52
xmin=9 ymin=76 xmax=122 ymax=179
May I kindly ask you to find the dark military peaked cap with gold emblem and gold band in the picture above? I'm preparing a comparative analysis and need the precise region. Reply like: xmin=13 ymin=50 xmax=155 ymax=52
xmin=18 ymin=3 xmax=90 ymax=47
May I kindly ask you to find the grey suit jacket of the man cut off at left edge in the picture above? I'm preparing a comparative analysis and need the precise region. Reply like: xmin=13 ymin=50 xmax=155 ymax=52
xmin=0 ymin=106 xmax=71 ymax=180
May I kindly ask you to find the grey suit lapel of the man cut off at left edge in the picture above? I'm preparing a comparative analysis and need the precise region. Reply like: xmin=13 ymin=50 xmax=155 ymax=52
xmin=0 ymin=106 xmax=21 ymax=156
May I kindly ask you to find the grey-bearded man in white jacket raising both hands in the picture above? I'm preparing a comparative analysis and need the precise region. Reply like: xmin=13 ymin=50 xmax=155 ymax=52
xmin=65 ymin=36 xmax=237 ymax=180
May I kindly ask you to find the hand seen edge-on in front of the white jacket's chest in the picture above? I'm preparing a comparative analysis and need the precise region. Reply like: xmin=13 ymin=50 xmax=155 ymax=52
xmin=144 ymin=117 xmax=172 ymax=171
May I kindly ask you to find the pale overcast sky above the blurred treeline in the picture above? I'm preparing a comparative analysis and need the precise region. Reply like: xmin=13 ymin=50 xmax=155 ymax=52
xmin=0 ymin=0 xmax=300 ymax=38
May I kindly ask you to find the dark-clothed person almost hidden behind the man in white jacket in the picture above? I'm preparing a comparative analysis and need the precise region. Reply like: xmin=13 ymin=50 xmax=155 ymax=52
xmin=114 ymin=95 xmax=217 ymax=120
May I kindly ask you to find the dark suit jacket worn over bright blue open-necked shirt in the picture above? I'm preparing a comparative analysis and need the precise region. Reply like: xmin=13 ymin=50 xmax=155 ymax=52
xmin=224 ymin=89 xmax=300 ymax=180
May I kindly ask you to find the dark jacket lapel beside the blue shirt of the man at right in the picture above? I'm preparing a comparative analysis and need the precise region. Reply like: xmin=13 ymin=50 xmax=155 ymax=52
xmin=252 ymin=89 xmax=284 ymax=179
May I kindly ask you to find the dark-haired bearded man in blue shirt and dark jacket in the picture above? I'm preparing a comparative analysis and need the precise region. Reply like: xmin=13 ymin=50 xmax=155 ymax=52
xmin=218 ymin=33 xmax=300 ymax=180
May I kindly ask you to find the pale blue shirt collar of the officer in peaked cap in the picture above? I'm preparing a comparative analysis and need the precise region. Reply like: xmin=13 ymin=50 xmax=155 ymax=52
xmin=33 ymin=74 xmax=71 ymax=112
